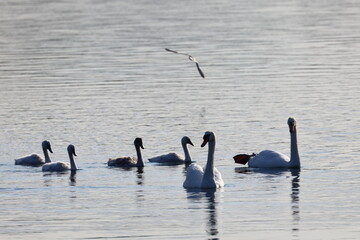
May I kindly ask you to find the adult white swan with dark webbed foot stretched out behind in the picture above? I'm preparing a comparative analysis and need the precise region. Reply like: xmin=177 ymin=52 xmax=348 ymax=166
xmin=234 ymin=117 xmax=300 ymax=168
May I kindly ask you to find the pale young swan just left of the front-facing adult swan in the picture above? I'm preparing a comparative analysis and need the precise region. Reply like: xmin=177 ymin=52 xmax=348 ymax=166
xmin=149 ymin=136 xmax=194 ymax=164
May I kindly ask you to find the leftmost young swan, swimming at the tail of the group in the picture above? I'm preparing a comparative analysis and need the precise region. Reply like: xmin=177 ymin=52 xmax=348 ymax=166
xmin=15 ymin=140 xmax=53 ymax=167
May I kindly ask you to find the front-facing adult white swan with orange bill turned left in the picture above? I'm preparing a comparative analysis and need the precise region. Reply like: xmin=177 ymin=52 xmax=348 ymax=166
xmin=183 ymin=132 xmax=224 ymax=188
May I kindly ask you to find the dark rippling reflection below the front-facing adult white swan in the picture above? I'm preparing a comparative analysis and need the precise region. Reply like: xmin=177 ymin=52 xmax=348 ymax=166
xmin=186 ymin=189 xmax=219 ymax=240
